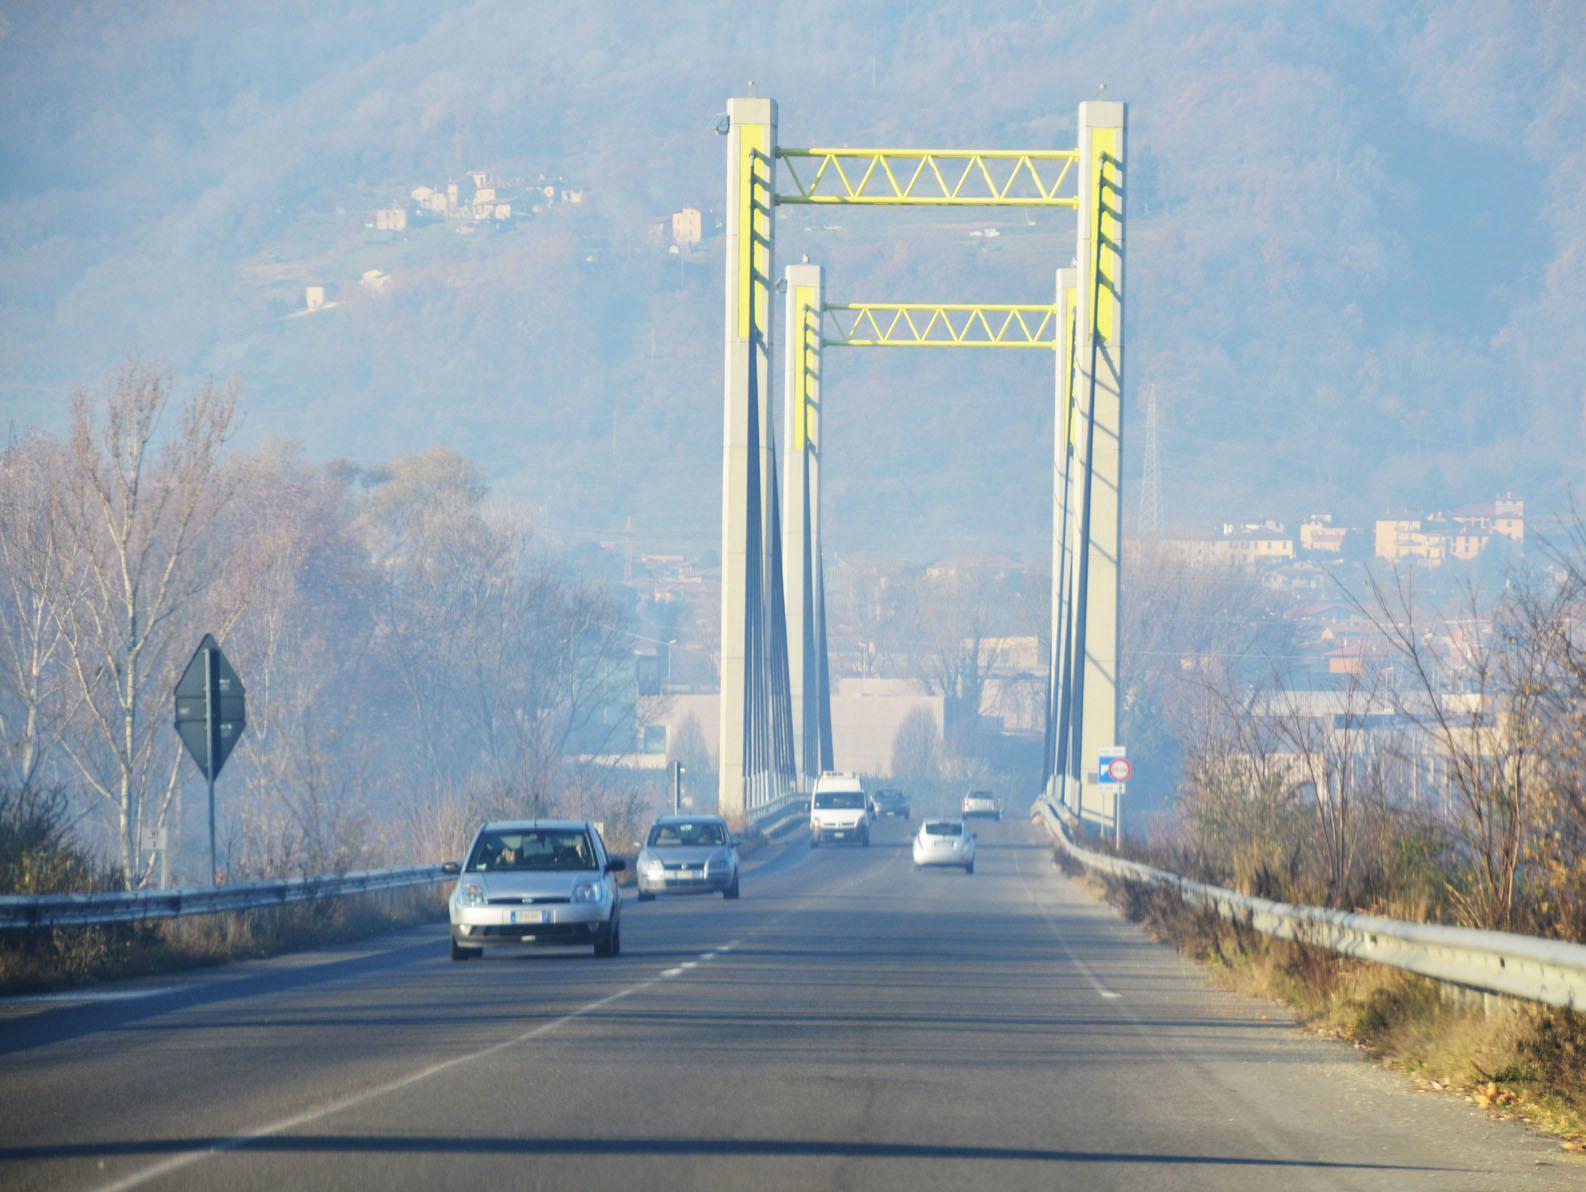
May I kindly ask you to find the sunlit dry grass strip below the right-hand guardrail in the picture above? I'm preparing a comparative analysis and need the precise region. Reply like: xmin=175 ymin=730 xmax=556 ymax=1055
xmin=1084 ymin=865 xmax=1586 ymax=1149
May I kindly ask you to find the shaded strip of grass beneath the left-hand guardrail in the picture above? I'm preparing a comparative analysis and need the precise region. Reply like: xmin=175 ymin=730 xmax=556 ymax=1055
xmin=0 ymin=883 xmax=446 ymax=994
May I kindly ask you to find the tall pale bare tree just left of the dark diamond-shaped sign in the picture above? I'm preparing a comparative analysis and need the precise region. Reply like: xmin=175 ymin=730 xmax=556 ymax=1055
xmin=51 ymin=361 xmax=236 ymax=886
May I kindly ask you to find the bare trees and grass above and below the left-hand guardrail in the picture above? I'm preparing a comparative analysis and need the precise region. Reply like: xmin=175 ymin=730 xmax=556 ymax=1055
xmin=0 ymin=367 xmax=665 ymax=989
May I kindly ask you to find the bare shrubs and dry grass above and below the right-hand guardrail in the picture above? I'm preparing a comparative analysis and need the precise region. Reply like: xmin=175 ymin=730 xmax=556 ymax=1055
xmin=1078 ymin=526 xmax=1586 ymax=1143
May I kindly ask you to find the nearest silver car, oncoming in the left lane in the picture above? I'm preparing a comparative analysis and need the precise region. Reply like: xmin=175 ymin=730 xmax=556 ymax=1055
xmin=446 ymin=820 xmax=626 ymax=961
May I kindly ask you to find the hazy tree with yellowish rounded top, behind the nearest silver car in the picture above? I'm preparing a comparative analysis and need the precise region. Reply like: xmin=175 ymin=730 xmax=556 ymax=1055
xmin=363 ymin=452 xmax=638 ymax=810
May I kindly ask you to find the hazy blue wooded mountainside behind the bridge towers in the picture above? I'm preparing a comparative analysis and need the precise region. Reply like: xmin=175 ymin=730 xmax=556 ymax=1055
xmin=0 ymin=0 xmax=1586 ymax=555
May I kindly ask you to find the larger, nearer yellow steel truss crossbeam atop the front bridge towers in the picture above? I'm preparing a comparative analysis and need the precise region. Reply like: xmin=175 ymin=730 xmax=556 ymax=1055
xmin=776 ymin=149 xmax=1080 ymax=208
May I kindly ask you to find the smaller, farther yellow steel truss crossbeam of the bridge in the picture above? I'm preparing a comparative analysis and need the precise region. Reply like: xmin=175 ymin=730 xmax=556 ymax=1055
xmin=820 ymin=303 xmax=1058 ymax=350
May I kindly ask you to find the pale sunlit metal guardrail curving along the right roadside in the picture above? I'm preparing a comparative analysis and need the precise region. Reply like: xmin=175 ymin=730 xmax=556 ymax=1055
xmin=1036 ymin=800 xmax=1586 ymax=1010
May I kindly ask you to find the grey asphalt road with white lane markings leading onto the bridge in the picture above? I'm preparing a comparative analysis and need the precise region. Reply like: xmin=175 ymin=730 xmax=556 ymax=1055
xmin=0 ymin=821 xmax=1586 ymax=1190
